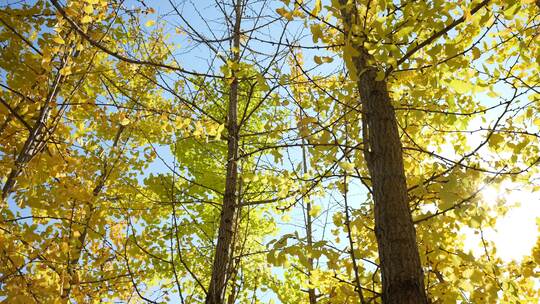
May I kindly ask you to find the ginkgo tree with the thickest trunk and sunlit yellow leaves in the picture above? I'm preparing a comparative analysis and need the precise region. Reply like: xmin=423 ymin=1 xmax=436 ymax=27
xmin=280 ymin=1 xmax=538 ymax=303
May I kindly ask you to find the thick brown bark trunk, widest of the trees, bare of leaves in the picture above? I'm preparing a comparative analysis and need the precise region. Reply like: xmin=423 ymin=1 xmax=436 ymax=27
xmin=340 ymin=0 xmax=428 ymax=304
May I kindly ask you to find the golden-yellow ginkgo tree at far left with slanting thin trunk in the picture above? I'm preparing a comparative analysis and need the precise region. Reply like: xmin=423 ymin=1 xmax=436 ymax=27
xmin=1 ymin=1 xmax=181 ymax=303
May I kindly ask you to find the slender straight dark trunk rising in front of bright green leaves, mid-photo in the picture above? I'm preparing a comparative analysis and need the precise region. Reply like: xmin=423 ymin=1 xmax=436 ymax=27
xmin=206 ymin=0 xmax=242 ymax=304
